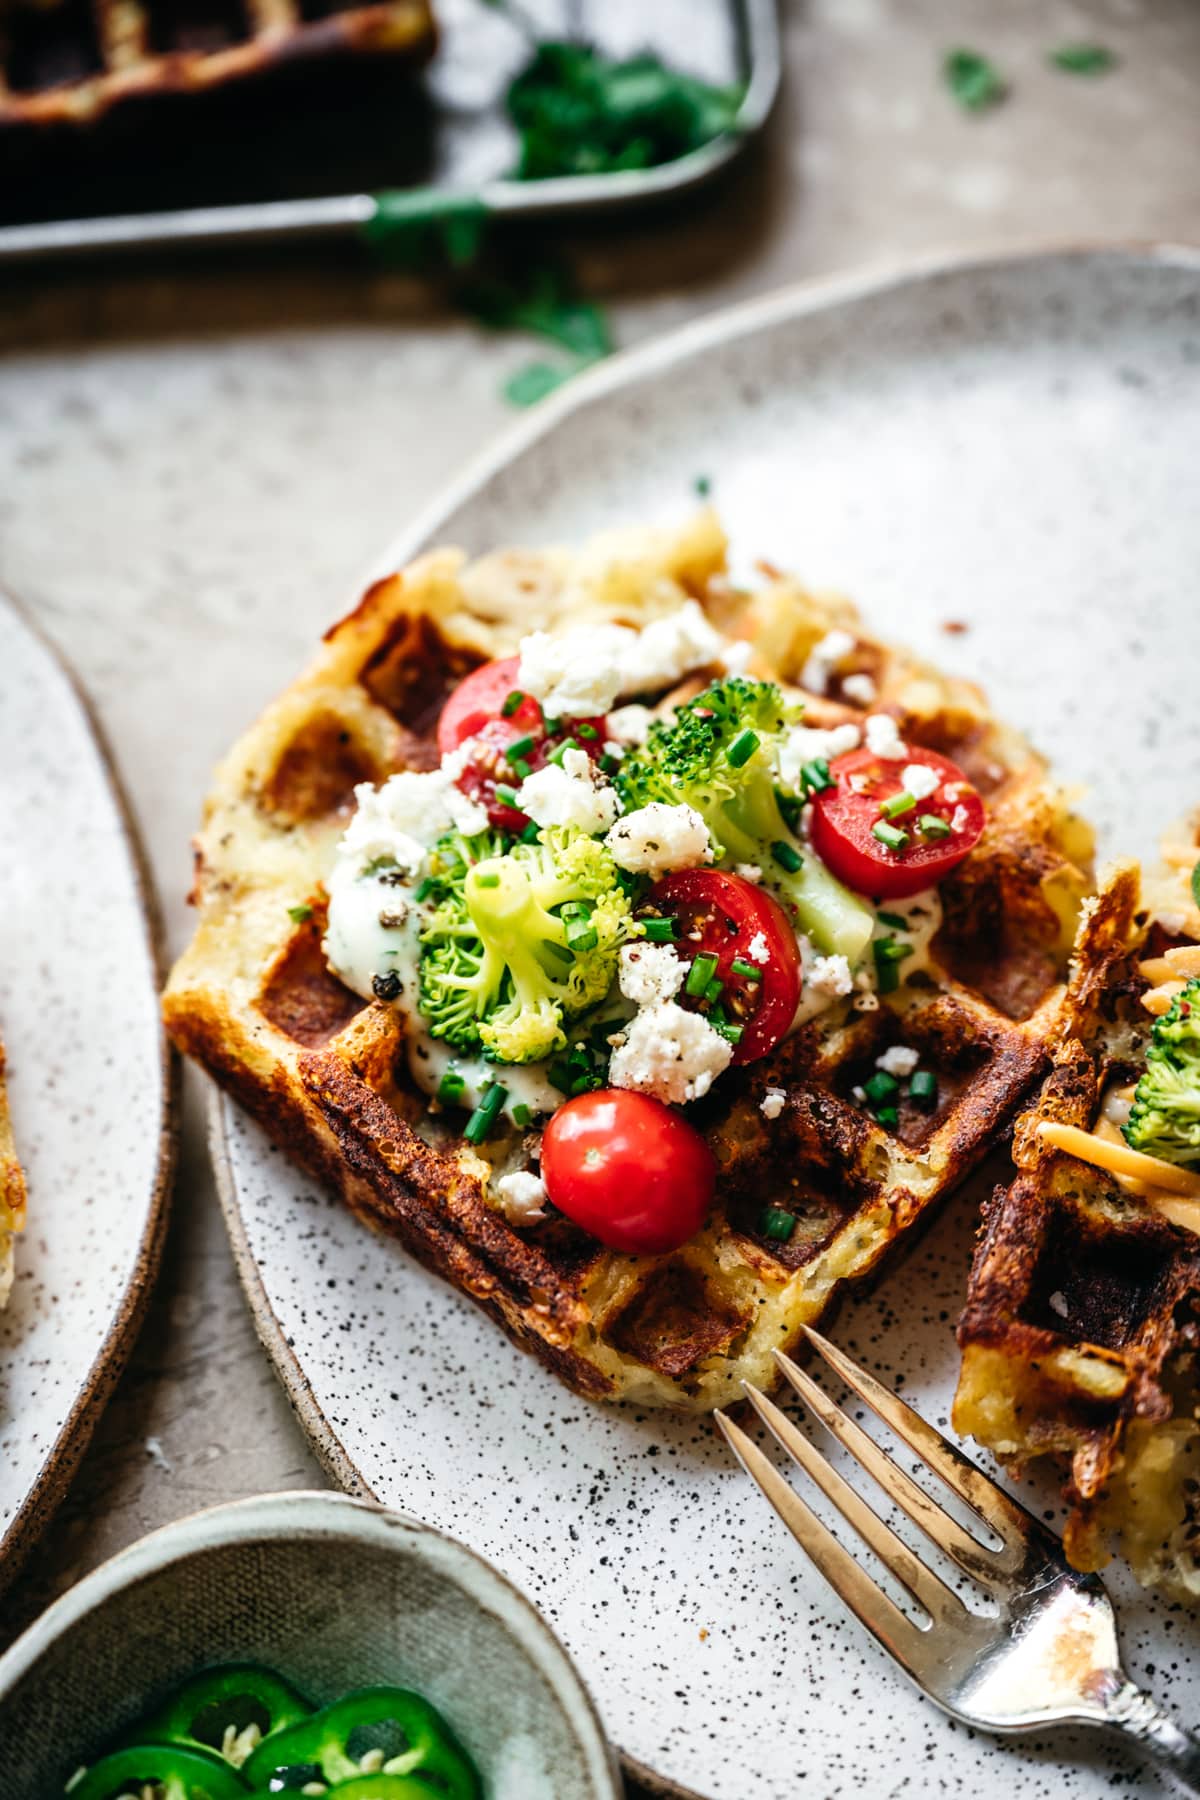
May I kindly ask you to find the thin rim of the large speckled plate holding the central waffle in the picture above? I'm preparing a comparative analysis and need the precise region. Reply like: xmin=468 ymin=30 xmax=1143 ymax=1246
xmin=207 ymin=238 xmax=1200 ymax=1800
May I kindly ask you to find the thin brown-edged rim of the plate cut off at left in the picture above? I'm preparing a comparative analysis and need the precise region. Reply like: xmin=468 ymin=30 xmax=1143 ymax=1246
xmin=0 ymin=589 xmax=180 ymax=1593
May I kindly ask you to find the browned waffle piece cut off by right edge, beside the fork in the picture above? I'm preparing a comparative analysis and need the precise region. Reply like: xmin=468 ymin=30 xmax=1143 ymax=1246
xmin=954 ymin=842 xmax=1200 ymax=1600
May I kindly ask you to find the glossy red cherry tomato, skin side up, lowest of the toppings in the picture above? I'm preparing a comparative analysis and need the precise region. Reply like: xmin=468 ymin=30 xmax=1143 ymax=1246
xmin=542 ymin=1087 xmax=716 ymax=1256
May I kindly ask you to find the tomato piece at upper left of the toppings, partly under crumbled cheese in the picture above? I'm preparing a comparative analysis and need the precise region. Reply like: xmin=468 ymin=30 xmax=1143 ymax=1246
xmin=437 ymin=657 xmax=608 ymax=833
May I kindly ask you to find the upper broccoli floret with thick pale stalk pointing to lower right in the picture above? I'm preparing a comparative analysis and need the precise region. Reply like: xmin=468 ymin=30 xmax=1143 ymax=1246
xmin=615 ymin=675 xmax=873 ymax=963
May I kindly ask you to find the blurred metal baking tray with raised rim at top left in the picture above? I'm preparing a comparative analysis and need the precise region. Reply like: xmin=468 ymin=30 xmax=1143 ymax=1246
xmin=0 ymin=0 xmax=779 ymax=263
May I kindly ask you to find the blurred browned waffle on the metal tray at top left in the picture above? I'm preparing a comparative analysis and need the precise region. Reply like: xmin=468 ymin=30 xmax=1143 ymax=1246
xmin=0 ymin=0 xmax=435 ymax=126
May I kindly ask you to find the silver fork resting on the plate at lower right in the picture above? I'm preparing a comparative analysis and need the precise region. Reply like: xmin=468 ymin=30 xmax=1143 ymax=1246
xmin=716 ymin=1330 xmax=1200 ymax=1795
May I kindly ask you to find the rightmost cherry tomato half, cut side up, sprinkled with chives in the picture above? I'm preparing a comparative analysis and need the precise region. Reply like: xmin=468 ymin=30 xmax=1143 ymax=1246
xmin=810 ymin=743 xmax=984 ymax=900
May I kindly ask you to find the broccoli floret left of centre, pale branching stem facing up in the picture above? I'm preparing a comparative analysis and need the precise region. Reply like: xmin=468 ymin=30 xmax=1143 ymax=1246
xmin=419 ymin=826 xmax=637 ymax=1062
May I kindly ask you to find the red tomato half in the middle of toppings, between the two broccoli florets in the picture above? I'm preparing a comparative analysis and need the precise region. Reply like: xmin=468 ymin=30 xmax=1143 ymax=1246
xmin=648 ymin=869 xmax=801 ymax=1062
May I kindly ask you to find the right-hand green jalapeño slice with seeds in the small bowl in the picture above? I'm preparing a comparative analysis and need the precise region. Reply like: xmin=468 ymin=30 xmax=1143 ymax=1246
xmin=243 ymin=1687 xmax=480 ymax=1800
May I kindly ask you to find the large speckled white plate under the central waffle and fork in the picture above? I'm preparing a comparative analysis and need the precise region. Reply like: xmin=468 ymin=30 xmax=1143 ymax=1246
xmin=216 ymin=252 xmax=1200 ymax=1800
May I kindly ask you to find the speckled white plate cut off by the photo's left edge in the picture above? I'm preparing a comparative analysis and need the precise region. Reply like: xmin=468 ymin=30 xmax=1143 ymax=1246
xmin=0 ymin=594 xmax=175 ymax=1586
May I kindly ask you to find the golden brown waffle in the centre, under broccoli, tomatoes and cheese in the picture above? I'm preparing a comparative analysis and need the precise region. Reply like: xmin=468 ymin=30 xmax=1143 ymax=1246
xmin=166 ymin=513 xmax=1090 ymax=1409
